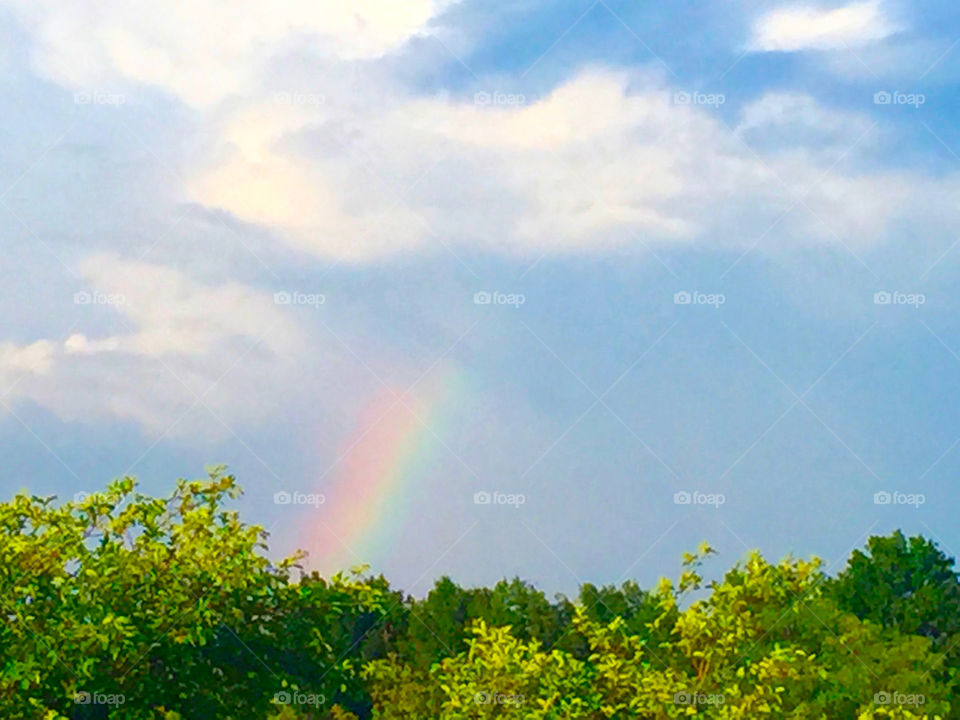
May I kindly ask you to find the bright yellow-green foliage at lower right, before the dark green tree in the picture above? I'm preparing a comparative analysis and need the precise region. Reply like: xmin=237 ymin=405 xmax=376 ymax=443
xmin=364 ymin=547 xmax=950 ymax=720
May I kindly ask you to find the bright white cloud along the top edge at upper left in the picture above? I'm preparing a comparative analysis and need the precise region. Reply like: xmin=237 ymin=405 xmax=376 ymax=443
xmin=7 ymin=0 xmax=449 ymax=107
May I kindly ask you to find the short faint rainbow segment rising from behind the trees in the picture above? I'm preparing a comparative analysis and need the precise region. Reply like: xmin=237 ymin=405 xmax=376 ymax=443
xmin=305 ymin=371 xmax=460 ymax=572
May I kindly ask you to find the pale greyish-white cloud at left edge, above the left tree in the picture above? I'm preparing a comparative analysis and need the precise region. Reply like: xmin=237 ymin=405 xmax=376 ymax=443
xmin=0 ymin=255 xmax=308 ymax=436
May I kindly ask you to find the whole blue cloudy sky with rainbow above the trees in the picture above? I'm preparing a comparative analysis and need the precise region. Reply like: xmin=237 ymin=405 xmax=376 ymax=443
xmin=0 ymin=0 xmax=960 ymax=595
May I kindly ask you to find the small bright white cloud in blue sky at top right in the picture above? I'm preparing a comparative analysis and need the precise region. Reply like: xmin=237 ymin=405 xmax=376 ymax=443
xmin=750 ymin=0 xmax=897 ymax=52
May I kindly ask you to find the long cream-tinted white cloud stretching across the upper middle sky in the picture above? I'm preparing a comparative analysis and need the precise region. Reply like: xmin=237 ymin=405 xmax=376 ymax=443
xmin=190 ymin=72 xmax=711 ymax=261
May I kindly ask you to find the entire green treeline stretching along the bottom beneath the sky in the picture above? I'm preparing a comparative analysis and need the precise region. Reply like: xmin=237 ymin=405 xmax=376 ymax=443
xmin=0 ymin=471 xmax=960 ymax=720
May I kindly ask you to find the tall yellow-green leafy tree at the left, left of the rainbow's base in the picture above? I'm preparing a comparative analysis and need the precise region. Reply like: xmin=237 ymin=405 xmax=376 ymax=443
xmin=0 ymin=469 xmax=388 ymax=720
